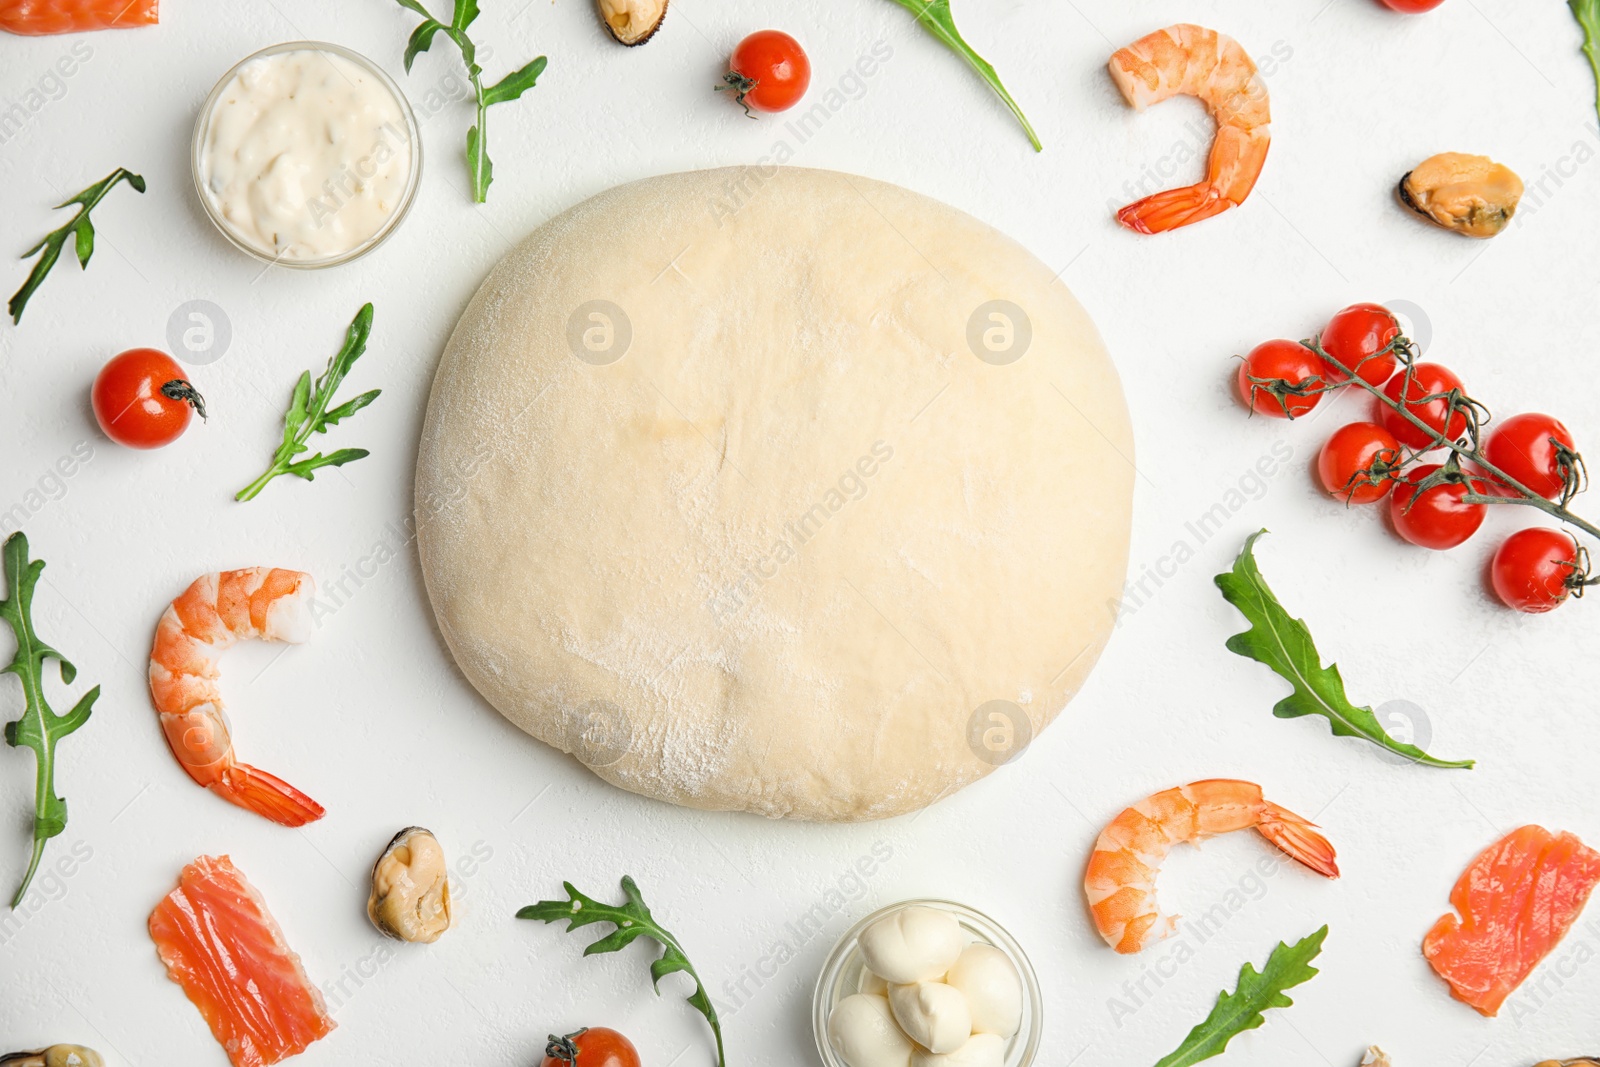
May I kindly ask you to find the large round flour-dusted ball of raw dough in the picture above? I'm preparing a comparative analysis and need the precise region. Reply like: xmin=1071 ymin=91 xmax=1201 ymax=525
xmin=416 ymin=168 xmax=1133 ymax=819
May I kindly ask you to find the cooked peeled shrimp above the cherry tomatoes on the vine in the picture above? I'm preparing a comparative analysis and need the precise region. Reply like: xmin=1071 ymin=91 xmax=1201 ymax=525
xmin=1110 ymin=22 xmax=1272 ymax=234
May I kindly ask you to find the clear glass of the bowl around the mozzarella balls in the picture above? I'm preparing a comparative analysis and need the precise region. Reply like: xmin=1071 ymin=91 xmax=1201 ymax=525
xmin=811 ymin=901 xmax=1045 ymax=1067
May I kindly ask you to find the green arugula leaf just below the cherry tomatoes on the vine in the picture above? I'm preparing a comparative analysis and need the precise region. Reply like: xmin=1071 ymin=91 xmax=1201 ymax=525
xmin=1216 ymin=530 xmax=1472 ymax=768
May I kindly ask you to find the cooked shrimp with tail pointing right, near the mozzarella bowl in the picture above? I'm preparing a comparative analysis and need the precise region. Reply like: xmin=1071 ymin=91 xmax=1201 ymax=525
xmin=1083 ymin=777 xmax=1339 ymax=952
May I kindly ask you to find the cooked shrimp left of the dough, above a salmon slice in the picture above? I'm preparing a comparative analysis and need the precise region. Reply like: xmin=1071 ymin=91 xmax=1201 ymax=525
xmin=150 ymin=566 xmax=323 ymax=825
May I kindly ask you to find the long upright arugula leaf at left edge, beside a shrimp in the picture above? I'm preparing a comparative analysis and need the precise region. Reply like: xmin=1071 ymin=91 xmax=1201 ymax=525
xmin=0 ymin=530 xmax=99 ymax=909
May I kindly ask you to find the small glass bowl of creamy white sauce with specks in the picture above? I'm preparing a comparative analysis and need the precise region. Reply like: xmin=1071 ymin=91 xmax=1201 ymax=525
xmin=190 ymin=40 xmax=422 ymax=270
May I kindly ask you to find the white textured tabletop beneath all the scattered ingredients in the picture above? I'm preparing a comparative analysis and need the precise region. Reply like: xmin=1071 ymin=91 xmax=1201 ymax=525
xmin=0 ymin=0 xmax=1600 ymax=1067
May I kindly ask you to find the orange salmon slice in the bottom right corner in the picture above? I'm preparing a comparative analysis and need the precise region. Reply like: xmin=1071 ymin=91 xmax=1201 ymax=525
xmin=1422 ymin=825 xmax=1600 ymax=1016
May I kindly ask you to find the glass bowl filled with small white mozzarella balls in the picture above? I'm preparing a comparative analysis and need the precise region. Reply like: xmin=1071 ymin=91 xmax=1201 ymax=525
xmin=811 ymin=901 xmax=1043 ymax=1067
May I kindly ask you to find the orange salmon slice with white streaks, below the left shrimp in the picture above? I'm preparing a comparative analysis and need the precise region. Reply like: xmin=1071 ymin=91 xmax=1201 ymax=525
xmin=150 ymin=856 xmax=336 ymax=1067
